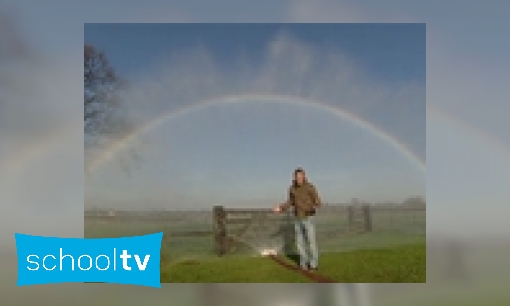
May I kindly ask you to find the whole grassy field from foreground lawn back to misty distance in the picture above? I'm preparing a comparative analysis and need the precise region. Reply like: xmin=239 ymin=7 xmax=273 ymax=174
xmin=85 ymin=212 xmax=426 ymax=283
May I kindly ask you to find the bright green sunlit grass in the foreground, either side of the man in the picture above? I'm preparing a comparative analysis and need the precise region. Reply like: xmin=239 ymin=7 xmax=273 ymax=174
xmin=161 ymin=244 xmax=426 ymax=283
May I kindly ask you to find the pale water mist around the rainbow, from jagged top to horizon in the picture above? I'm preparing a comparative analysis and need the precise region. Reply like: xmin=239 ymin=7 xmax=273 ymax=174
xmin=85 ymin=25 xmax=425 ymax=215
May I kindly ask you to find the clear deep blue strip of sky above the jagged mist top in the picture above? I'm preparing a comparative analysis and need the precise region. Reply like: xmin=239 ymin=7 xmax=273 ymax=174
xmin=84 ymin=24 xmax=426 ymax=83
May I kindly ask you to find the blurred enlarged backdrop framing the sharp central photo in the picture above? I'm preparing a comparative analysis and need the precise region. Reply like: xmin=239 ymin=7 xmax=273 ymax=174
xmin=0 ymin=0 xmax=509 ymax=306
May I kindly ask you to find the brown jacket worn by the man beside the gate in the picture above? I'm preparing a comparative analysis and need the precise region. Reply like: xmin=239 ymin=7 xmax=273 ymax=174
xmin=280 ymin=181 xmax=321 ymax=218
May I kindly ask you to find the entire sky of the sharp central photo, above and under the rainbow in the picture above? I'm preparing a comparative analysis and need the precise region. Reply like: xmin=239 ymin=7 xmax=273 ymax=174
xmin=84 ymin=24 xmax=425 ymax=208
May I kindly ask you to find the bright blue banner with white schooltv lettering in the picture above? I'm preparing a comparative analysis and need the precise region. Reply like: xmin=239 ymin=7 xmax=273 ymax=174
xmin=14 ymin=233 xmax=163 ymax=288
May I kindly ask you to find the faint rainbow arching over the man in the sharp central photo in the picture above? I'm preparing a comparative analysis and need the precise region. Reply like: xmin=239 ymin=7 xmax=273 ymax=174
xmin=85 ymin=94 xmax=426 ymax=175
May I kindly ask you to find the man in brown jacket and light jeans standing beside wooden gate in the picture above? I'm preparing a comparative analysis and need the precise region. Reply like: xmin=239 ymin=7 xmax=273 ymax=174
xmin=273 ymin=168 xmax=321 ymax=270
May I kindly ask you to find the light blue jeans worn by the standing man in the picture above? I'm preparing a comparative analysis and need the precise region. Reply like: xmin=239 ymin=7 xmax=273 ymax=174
xmin=294 ymin=216 xmax=319 ymax=268
